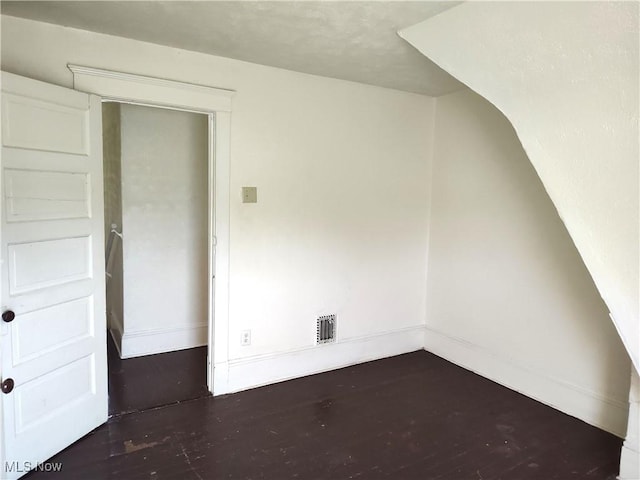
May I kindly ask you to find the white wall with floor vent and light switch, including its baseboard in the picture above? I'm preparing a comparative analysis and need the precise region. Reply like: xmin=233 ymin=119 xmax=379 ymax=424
xmin=2 ymin=17 xmax=434 ymax=389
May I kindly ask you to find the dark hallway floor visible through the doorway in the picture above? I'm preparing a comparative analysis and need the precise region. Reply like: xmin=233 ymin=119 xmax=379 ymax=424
xmin=107 ymin=335 xmax=209 ymax=416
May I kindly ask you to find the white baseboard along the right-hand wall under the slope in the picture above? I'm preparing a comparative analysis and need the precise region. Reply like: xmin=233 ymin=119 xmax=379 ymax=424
xmin=424 ymin=327 xmax=629 ymax=438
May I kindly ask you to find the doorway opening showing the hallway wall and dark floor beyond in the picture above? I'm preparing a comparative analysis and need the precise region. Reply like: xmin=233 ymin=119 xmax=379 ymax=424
xmin=102 ymin=101 xmax=210 ymax=416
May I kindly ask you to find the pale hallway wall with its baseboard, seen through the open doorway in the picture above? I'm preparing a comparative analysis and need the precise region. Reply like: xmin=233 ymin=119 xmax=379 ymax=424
xmin=120 ymin=105 xmax=208 ymax=357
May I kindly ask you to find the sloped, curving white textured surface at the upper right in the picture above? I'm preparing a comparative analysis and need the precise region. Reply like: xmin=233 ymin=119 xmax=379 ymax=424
xmin=401 ymin=2 xmax=640 ymax=376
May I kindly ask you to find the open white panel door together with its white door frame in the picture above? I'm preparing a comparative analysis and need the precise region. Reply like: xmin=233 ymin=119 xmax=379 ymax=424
xmin=0 ymin=65 xmax=233 ymax=478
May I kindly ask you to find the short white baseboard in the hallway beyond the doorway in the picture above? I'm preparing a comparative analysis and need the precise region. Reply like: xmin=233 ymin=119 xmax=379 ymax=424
xmin=120 ymin=323 xmax=207 ymax=358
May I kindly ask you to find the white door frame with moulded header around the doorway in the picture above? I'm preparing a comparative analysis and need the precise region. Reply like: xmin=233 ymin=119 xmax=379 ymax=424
xmin=68 ymin=64 xmax=235 ymax=395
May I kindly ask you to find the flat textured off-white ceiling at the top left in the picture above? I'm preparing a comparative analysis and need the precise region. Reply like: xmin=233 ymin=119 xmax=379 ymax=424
xmin=1 ymin=0 xmax=462 ymax=96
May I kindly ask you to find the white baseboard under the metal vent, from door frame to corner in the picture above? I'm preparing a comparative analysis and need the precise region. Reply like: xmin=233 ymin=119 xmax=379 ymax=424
xmin=213 ymin=325 xmax=424 ymax=395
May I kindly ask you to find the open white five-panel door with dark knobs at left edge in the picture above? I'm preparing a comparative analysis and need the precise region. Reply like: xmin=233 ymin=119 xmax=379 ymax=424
xmin=0 ymin=72 xmax=107 ymax=479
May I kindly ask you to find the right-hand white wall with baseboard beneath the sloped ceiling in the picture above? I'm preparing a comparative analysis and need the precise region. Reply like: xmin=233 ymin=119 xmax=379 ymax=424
xmin=425 ymin=90 xmax=630 ymax=436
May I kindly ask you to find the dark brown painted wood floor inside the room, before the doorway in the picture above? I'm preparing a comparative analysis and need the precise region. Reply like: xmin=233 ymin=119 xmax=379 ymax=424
xmin=28 ymin=351 xmax=622 ymax=480
